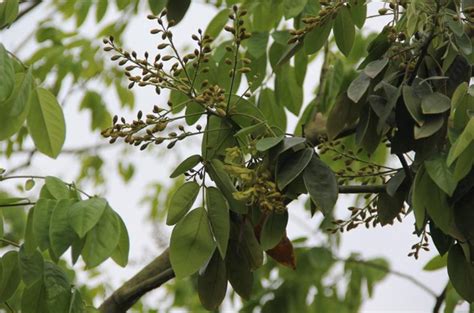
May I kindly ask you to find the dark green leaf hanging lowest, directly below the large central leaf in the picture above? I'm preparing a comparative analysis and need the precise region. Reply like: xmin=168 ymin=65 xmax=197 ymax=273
xmin=198 ymin=251 xmax=227 ymax=310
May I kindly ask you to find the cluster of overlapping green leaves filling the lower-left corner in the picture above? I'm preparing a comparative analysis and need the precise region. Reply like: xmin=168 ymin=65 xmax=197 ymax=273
xmin=0 ymin=176 xmax=129 ymax=312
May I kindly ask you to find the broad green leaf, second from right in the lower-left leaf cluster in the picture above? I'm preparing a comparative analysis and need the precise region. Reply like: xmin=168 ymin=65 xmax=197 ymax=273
xmin=81 ymin=205 xmax=120 ymax=268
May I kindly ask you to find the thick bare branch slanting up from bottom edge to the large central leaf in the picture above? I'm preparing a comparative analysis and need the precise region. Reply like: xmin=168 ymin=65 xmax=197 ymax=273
xmin=99 ymin=249 xmax=174 ymax=313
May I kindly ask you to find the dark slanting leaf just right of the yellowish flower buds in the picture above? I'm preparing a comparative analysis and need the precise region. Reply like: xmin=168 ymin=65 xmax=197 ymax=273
xmin=276 ymin=148 xmax=314 ymax=190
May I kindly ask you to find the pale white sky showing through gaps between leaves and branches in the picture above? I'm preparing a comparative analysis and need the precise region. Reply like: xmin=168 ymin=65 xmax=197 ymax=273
xmin=0 ymin=1 xmax=460 ymax=312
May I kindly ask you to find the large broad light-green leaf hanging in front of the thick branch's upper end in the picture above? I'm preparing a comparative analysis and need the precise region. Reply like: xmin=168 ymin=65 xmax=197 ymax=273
xmin=170 ymin=207 xmax=216 ymax=278
